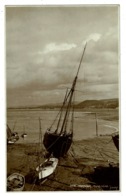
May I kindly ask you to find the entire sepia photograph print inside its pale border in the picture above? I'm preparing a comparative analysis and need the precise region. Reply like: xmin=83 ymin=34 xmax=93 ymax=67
xmin=5 ymin=4 xmax=120 ymax=192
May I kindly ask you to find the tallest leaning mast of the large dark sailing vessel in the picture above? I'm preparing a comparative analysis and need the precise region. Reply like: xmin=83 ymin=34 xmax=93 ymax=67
xmin=60 ymin=43 xmax=87 ymax=134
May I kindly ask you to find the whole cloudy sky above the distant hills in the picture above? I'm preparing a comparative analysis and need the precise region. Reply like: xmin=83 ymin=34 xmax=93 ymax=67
xmin=6 ymin=5 xmax=120 ymax=107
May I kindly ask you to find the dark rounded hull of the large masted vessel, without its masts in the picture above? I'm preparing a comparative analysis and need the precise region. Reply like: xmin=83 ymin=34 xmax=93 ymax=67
xmin=43 ymin=132 xmax=72 ymax=158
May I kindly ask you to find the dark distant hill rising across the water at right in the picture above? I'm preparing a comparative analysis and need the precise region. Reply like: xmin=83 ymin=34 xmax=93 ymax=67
xmin=76 ymin=99 xmax=119 ymax=109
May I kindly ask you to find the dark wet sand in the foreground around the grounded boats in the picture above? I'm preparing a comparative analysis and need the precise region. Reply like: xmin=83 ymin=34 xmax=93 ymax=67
xmin=7 ymin=135 xmax=119 ymax=191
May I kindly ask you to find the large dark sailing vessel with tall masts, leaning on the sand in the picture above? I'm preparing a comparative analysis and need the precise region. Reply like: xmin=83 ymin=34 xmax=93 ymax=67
xmin=43 ymin=45 xmax=86 ymax=157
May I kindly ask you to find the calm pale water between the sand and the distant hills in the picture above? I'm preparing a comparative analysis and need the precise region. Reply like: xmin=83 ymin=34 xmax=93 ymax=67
xmin=7 ymin=109 xmax=118 ymax=143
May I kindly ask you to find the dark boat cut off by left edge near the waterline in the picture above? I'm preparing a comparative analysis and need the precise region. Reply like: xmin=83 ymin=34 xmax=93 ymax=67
xmin=7 ymin=125 xmax=19 ymax=144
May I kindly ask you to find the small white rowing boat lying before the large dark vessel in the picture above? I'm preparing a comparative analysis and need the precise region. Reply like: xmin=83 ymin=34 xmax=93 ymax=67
xmin=36 ymin=157 xmax=58 ymax=180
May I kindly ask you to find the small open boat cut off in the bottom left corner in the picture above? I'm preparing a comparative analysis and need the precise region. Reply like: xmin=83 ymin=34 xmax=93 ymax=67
xmin=7 ymin=173 xmax=25 ymax=191
